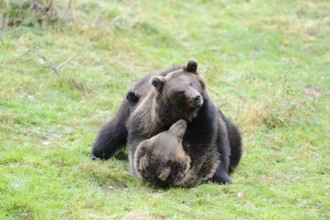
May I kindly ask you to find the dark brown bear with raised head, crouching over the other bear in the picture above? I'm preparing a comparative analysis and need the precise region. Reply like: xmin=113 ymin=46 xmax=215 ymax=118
xmin=92 ymin=61 xmax=242 ymax=185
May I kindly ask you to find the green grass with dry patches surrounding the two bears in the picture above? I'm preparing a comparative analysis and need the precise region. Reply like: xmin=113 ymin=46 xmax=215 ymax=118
xmin=0 ymin=0 xmax=330 ymax=219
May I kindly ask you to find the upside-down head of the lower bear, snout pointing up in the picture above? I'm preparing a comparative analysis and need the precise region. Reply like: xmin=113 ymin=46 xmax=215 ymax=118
xmin=134 ymin=120 xmax=190 ymax=187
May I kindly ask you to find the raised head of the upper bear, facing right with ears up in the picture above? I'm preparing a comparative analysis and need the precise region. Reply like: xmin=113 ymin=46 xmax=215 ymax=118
xmin=151 ymin=60 xmax=205 ymax=122
